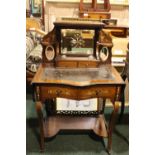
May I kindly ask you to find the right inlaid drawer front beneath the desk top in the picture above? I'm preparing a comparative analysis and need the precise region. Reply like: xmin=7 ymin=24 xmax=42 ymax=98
xmin=78 ymin=86 xmax=116 ymax=99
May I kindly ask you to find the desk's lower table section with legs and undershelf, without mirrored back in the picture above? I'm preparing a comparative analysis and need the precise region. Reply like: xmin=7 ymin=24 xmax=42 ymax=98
xmin=32 ymin=64 xmax=124 ymax=152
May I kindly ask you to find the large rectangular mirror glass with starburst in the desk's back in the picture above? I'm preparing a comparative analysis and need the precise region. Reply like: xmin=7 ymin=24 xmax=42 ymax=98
xmin=61 ymin=29 xmax=95 ymax=55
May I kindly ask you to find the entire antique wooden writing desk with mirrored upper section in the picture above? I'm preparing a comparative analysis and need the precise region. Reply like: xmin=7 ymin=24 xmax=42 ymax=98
xmin=32 ymin=17 xmax=124 ymax=152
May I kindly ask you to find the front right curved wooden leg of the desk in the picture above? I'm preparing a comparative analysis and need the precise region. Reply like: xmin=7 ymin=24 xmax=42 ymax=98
xmin=107 ymin=101 xmax=119 ymax=154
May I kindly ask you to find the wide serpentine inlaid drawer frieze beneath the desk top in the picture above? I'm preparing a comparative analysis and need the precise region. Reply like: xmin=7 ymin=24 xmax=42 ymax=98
xmin=40 ymin=85 xmax=116 ymax=102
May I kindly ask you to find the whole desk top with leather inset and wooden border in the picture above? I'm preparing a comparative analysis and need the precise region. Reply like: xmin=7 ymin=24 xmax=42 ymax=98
xmin=32 ymin=65 xmax=124 ymax=86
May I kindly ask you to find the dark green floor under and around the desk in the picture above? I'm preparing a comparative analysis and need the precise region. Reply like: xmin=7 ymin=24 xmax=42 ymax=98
xmin=26 ymin=93 xmax=129 ymax=155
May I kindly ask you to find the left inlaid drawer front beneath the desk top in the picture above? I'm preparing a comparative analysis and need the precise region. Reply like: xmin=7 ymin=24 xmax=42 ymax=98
xmin=40 ymin=86 xmax=77 ymax=101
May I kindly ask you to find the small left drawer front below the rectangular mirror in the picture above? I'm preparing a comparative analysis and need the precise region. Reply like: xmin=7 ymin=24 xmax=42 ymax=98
xmin=56 ymin=61 xmax=77 ymax=68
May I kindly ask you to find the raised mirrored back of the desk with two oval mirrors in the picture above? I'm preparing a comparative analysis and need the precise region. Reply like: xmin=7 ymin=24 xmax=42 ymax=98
xmin=42 ymin=18 xmax=112 ymax=68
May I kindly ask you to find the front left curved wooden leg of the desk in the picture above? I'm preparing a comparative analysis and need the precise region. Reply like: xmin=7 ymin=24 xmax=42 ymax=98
xmin=36 ymin=102 xmax=44 ymax=152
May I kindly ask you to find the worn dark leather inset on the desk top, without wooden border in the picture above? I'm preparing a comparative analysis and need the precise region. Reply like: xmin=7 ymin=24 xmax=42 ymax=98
xmin=42 ymin=66 xmax=114 ymax=82
